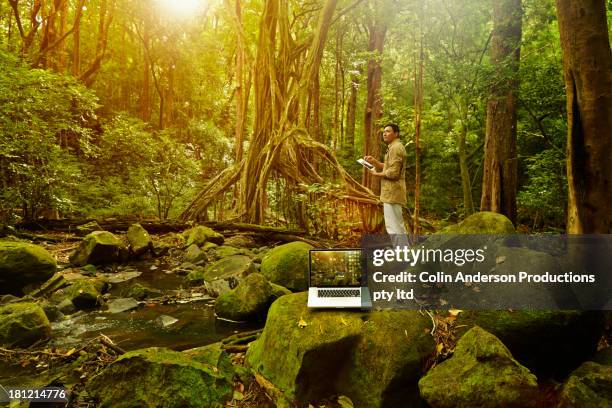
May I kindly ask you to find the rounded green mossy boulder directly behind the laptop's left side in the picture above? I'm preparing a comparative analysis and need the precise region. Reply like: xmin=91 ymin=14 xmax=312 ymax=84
xmin=260 ymin=241 xmax=314 ymax=291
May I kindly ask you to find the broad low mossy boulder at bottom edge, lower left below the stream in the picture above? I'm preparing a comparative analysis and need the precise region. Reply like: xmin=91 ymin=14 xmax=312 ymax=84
xmin=86 ymin=347 xmax=232 ymax=408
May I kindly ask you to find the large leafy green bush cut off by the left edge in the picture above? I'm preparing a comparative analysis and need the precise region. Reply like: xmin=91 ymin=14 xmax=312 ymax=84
xmin=0 ymin=51 xmax=98 ymax=222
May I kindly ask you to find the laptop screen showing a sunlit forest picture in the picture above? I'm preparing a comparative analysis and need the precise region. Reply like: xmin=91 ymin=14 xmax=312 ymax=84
xmin=310 ymin=249 xmax=365 ymax=287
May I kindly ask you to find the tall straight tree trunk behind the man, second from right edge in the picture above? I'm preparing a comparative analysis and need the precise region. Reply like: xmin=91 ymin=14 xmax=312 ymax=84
xmin=480 ymin=0 xmax=522 ymax=223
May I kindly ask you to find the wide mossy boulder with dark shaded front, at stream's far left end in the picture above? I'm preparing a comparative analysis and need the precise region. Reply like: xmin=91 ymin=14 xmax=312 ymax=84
xmin=70 ymin=231 xmax=126 ymax=266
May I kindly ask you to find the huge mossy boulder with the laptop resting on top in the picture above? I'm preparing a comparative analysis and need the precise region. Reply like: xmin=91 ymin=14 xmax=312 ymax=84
xmin=246 ymin=292 xmax=435 ymax=407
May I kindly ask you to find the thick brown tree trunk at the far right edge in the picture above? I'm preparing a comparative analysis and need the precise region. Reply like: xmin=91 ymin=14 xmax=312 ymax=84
xmin=557 ymin=0 xmax=612 ymax=234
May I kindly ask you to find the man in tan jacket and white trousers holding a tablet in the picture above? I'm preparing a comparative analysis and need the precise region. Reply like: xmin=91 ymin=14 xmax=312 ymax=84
xmin=364 ymin=123 xmax=406 ymax=244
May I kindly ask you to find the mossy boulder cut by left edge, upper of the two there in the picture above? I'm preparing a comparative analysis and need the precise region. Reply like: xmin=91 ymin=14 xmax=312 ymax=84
xmin=0 ymin=241 xmax=56 ymax=295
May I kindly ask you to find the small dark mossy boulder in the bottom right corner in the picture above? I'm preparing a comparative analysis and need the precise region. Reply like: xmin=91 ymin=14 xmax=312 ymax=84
xmin=558 ymin=361 xmax=612 ymax=408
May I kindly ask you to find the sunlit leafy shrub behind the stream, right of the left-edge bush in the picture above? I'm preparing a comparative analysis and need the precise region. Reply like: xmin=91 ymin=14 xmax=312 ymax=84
xmin=82 ymin=115 xmax=198 ymax=219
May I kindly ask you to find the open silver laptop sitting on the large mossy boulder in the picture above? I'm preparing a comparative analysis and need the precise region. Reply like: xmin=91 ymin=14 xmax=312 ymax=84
xmin=308 ymin=249 xmax=372 ymax=309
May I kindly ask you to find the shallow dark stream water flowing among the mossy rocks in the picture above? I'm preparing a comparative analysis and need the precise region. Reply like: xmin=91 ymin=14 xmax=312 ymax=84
xmin=50 ymin=262 xmax=263 ymax=350
